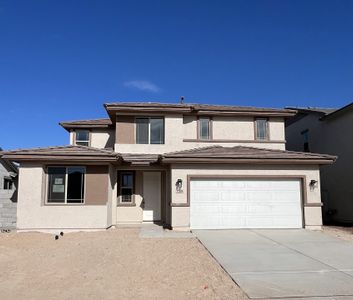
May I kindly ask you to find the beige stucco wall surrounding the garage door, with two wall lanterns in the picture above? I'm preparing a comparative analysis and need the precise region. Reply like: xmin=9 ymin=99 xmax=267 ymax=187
xmin=170 ymin=164 xmax=322 ymax=230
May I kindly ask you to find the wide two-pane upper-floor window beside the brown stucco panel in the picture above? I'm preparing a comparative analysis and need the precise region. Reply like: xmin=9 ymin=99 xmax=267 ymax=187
xmin=136 ymin=117 xmax=164 ymax=144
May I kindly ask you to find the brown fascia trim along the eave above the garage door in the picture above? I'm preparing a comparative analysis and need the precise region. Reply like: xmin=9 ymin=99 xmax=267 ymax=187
xmin=162 ymin=157 xmax=334 ymax=165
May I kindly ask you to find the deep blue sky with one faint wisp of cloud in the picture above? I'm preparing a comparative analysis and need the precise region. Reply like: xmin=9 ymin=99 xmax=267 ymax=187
xmin=0 ymin=0 xmax=353 ymax=149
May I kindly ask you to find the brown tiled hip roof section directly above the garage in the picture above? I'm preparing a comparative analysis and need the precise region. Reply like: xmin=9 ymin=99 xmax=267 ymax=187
xmin=163 ymin=146 xmax=336 ymax=164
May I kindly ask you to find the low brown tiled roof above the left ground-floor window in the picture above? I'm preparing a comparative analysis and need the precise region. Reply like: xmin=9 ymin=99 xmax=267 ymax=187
xmin=2 ymin=145 xmax=118 ymax=162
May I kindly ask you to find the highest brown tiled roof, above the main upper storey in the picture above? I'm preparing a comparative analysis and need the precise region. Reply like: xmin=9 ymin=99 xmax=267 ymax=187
xmin=104 ymin=102 xmax=296 ymax=118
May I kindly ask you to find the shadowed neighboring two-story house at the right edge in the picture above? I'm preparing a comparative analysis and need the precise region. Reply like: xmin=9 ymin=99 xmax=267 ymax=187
xmin=286 ymin=103 xmax=353 ymax=224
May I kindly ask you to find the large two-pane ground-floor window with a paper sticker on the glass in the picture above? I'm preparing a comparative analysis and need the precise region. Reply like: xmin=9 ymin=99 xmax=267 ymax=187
xmin=47 ymin=166 xmax=86 ymax=204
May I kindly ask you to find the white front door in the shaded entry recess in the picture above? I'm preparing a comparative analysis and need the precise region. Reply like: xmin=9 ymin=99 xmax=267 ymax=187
xmin=143 ymin=172 xmax=161 ymax=221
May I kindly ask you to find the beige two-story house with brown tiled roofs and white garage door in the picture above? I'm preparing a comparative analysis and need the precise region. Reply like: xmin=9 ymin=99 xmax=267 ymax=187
xmin=4 ymin=103 xmax=335 ymax=230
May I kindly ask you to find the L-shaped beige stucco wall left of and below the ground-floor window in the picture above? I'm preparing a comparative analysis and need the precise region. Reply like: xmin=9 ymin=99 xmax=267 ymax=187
xmin=17 ymin=164 xmax=107 ymax=231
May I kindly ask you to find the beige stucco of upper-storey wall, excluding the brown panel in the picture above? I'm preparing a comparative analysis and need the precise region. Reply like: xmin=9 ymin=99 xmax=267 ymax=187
xmin=115 ymin=114 xmax=285 ymax=154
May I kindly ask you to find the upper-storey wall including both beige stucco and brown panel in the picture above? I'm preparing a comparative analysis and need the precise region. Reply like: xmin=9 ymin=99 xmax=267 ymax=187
xmin=115 ymin=114 xmax=285 ymax=154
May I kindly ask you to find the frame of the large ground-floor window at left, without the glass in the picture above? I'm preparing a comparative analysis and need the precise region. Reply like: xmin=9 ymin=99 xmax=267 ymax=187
xmin=44 ymin=165 xmax=87 ymax=206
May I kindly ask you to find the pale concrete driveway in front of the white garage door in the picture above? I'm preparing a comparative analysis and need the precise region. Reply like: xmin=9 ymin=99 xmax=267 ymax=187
xmin=194 ymin=229 xmax=353 ymax=300
